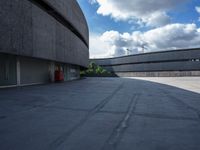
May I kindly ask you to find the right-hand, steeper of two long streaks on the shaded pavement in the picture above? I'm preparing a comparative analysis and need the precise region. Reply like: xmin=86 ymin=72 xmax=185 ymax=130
xmin=101 ymin=94 xmax=140 ymax=150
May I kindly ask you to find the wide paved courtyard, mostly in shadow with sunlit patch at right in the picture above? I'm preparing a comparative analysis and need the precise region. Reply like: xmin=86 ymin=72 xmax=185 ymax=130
xmin=0 ymin=77 xmax=200 ymax=150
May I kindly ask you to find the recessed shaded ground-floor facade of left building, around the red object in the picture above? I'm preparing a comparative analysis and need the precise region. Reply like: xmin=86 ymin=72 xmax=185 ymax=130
xmin=0 ymin=54 xmax=80 ymax=88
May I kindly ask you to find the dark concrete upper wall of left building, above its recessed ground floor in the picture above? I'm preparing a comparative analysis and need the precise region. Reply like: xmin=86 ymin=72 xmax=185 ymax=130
xmin=0 ymin=0 xmax=89 ymax=67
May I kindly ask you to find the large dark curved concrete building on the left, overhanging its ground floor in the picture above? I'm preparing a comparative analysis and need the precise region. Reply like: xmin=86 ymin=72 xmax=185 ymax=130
xmin=0 ymin=0 xmax=89 ymax=86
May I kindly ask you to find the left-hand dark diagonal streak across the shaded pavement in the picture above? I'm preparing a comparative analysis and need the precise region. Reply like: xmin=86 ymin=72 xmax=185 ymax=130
xmin=48 ymin=83 xmax=123 ymax=150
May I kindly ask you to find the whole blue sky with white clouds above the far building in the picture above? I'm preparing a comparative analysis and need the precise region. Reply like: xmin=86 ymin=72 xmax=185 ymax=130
xmin=77 ymin=0 xmax=200 ymax=58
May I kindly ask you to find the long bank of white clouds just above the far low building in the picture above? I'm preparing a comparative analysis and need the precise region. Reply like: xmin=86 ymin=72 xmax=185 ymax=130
xmin=90 ymin=24 xmax=200 ymax=57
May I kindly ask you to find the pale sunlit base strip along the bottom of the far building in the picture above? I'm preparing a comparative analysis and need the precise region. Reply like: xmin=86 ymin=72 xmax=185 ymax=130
xmin=115 ymin=71 xmax=200 ymax=77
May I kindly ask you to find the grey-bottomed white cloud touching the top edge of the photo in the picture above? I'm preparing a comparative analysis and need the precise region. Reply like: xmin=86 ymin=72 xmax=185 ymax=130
xmin=92 ymin=0 xmax=186 ymax=27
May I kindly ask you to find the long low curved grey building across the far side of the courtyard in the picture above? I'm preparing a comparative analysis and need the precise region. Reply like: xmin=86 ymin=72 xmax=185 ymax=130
xmin=91 ymin=49 xmax=200 ymax=77
